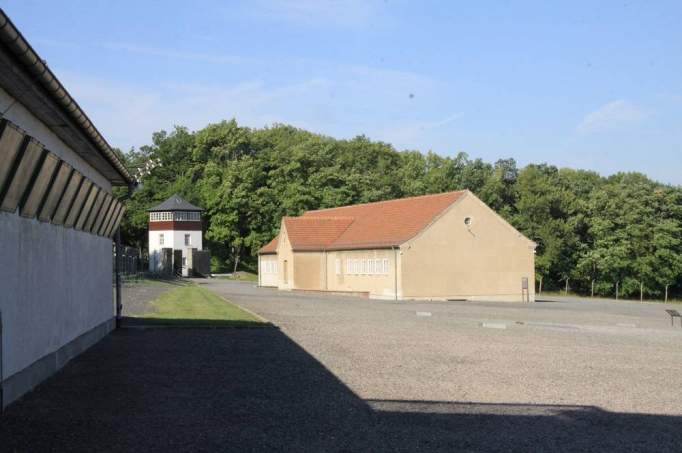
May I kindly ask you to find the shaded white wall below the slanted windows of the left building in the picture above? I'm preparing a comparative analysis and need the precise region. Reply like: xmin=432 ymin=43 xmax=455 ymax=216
xmin=0 ymin=212 xmax=115 ymax=379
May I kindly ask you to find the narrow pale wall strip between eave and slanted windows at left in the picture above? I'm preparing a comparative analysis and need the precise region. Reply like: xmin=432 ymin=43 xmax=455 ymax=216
xmin=0 ymin=88 xmax=111 ymax=192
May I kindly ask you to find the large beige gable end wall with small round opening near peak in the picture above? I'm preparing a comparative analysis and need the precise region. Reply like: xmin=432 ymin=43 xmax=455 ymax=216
xmin=401 ymin=193 xmax=535 ymax=301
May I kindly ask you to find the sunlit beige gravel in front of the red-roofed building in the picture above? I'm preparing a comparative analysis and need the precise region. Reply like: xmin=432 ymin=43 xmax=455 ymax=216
xmin=207 ymin=281 xmax=682 ymax=414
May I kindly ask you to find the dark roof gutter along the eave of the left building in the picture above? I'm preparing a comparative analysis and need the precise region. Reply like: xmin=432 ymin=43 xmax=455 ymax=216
xmin=0 ymin=9 xmax=135 ymax=184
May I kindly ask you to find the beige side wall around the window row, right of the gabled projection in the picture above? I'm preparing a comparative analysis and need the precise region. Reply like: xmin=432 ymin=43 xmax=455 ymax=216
xmin=326 ymin=249 xmax=400 ymax=299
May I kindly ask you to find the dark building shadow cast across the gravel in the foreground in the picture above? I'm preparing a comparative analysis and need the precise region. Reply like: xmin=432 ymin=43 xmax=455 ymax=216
xmin=0 ymin=329 xmax=682 ymax=452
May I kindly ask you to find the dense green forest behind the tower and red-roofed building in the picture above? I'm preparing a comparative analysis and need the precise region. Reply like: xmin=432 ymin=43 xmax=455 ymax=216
xmin=114 ymin=120 xmax=682 ymax=298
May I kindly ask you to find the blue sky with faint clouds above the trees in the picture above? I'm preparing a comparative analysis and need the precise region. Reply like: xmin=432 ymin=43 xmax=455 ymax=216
xmin=5 ymin=0 xmax=682 ymax=185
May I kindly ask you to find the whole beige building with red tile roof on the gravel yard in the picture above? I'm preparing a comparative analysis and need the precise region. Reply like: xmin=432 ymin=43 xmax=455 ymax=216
xmin=258 ymin=190 xmax=535 ymax=300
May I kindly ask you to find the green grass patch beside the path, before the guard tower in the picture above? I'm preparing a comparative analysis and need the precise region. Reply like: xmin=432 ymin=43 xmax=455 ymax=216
xmin=133 ymin=284 xmax=267 ymax=327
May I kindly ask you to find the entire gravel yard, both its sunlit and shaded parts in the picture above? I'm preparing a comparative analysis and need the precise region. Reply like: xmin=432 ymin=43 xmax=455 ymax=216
xmin=0 ymin=281 xmax=682 ymax=452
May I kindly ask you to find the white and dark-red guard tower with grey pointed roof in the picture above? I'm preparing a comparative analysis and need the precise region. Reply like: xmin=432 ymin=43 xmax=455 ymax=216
xmin=148 ymin=195 xmax=203 ymax=277
